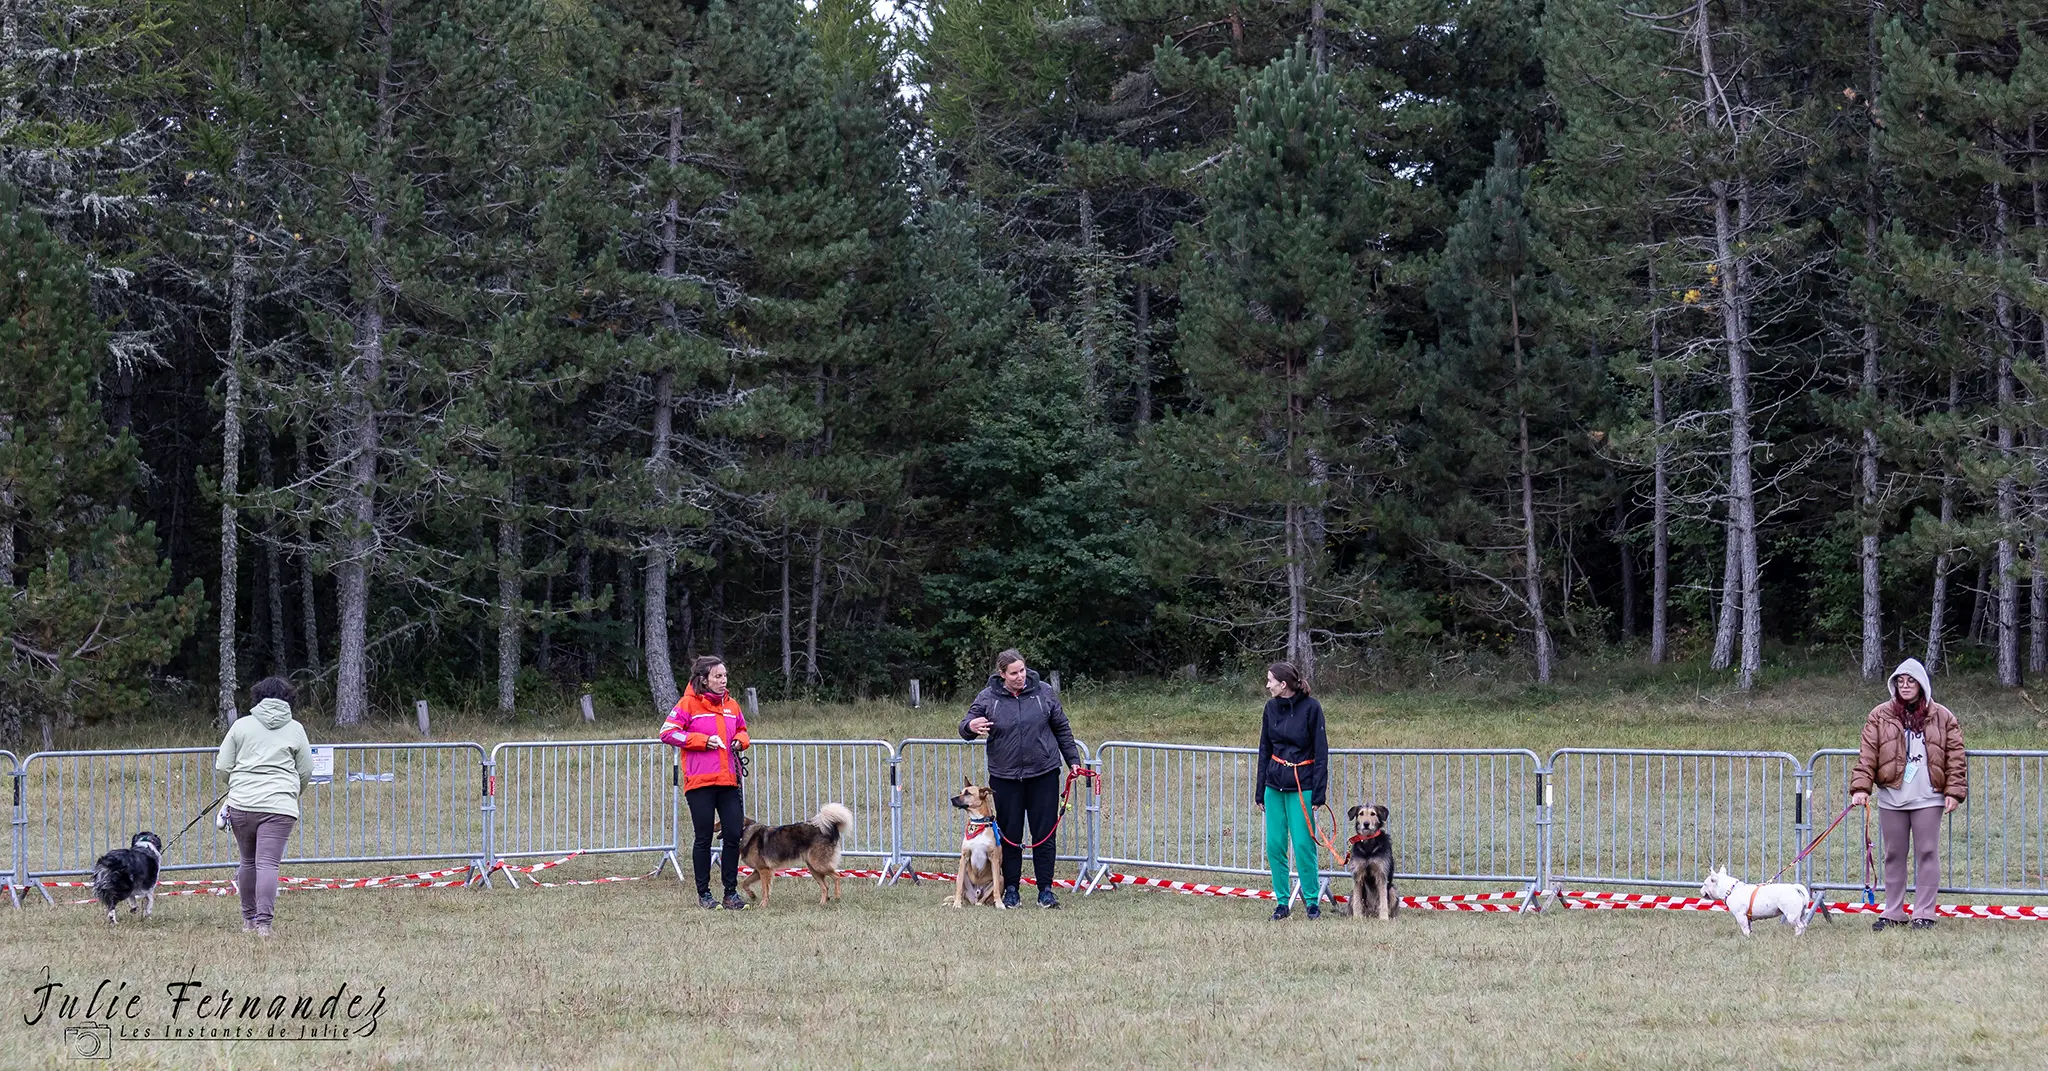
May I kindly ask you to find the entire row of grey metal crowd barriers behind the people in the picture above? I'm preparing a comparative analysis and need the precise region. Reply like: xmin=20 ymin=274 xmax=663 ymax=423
xmin=0 ymin=737 xmax=2048 ymax=905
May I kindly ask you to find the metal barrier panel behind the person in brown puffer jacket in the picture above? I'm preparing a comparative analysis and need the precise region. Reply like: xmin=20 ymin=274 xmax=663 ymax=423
xmin=1808 ymin=747 xmax=2048 ymax=899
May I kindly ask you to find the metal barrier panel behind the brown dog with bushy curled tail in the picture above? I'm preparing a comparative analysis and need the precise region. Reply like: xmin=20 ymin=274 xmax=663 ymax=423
xmin=741 ymin=739 xmax=895 ymax=860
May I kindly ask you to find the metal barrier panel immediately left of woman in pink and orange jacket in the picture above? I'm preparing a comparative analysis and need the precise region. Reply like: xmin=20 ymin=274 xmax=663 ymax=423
xmin=489 ymin=739 xmax=682 ymax=876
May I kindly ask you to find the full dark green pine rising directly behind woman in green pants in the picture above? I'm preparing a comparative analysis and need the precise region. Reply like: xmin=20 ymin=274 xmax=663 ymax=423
xmin=1149 ymin=43 xmax=1395 ymax=678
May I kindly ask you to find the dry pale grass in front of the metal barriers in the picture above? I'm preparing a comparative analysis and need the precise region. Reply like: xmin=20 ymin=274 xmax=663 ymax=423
xmin=0 ymin=876 xmax=2048 ymax=1069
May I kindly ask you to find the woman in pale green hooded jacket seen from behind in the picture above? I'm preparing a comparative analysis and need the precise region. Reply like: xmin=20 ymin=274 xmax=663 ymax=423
xmin=213 ymin=678 xmax=313 ymax=938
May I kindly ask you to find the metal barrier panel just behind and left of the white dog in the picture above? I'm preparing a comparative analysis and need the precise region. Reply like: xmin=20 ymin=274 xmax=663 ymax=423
xmin=1548 ymin=747 xmax=1806 ymax=887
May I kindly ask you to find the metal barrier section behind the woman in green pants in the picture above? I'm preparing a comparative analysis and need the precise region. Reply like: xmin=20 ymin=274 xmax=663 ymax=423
xmin=1100 ymin=739 xmax=1542 ymax=885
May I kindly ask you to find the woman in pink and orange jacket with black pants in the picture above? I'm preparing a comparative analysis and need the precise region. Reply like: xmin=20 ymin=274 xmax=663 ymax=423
xmin=662 ymin=655 xmax=750 ymax=911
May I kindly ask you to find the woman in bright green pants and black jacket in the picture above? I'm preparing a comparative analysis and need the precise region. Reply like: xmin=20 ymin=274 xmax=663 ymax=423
xmin=1251 ymin=661 xmax=1329 ymax=922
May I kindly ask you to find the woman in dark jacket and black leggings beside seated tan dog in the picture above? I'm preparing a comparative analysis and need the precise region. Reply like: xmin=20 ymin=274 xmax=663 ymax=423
xmin=961 ymin=651 xmax=1081 ymax=907
